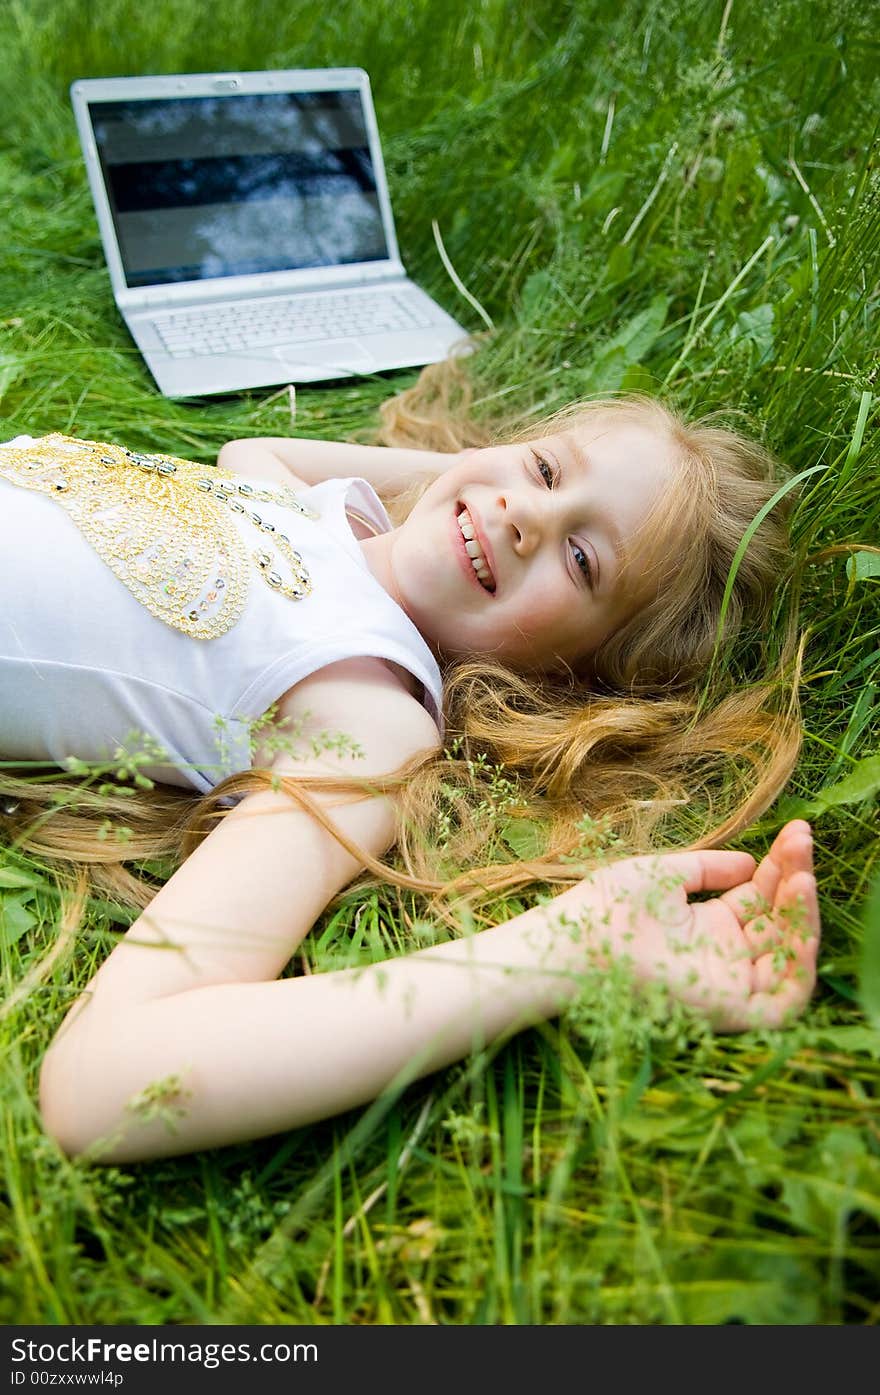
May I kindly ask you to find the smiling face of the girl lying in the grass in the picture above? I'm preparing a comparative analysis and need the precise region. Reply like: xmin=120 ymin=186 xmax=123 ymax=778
xmin=361 ymin=414 xmax=674 ymax=671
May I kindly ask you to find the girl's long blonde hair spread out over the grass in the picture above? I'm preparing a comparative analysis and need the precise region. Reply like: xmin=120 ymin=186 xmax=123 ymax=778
xmin=0 ymin=361 xmax=801 ymax=915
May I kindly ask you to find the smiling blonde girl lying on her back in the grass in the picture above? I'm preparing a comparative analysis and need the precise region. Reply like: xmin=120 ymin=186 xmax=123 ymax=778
xmin=0 ymin=374 xmax=819 ymax=1162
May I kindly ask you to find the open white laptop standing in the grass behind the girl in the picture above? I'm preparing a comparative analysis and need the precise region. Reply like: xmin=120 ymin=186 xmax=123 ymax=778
xmin=71 ymin=68 xmax=467 ymax=398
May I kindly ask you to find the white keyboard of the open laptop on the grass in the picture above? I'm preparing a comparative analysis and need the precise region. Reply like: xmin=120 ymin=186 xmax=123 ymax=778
xmin=153 ymin=290 xmax=432 ymax=359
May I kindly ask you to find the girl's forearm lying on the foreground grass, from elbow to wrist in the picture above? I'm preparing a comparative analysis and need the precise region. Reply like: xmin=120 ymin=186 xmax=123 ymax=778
xmin=44 ymin=893 xmax=586 ymax=1162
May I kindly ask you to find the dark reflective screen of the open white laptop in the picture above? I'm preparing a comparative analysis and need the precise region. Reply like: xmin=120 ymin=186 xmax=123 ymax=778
xmin=89 ymin=91 xmax=389 ymax=287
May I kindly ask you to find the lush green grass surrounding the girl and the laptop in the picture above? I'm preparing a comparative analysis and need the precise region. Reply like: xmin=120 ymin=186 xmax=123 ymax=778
xmin=0 ymin=0 xmax=880 ymax=1324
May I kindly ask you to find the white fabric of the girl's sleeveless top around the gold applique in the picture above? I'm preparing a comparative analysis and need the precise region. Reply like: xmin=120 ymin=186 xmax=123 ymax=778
xmin=0 ymin=437 xmax=442 ymax=792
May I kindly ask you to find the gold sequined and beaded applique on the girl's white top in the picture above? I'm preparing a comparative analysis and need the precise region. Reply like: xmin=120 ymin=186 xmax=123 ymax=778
xmin=0 ymin=432 xmax=318 ymax=639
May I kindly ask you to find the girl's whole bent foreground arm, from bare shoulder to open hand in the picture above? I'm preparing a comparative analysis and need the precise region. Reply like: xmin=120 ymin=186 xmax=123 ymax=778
xmin=34 ymin=660 xmax=817 ymax=1162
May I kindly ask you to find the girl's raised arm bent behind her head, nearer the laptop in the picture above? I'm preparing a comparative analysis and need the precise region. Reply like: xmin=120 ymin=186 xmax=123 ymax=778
xmin=218 ymin=437 xmax=456 ymax=494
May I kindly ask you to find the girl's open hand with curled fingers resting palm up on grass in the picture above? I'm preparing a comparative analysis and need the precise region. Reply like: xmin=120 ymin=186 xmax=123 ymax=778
xmin=558 ymin=820 xmax=820 ymax=1032
